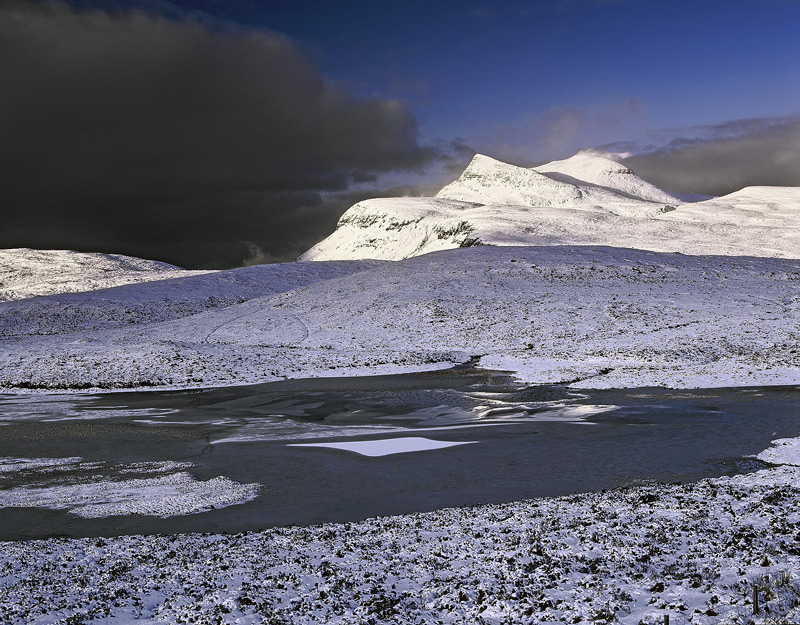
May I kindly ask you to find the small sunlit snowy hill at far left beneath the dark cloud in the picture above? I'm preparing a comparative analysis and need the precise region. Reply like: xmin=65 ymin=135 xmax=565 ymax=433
xmin=0 ymin=248 xmax=206 ymax=302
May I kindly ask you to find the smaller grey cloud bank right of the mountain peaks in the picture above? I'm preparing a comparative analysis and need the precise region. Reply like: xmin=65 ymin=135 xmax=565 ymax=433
xmin=605 ymin=116 xmax=800 ymax=195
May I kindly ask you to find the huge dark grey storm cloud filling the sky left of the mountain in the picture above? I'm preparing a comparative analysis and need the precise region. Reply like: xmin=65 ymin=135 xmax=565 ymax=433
xmin=0 ymin=2 xmax=437 ymax=266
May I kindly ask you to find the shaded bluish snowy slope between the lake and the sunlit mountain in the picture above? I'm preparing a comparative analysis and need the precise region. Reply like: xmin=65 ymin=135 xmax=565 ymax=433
xmin=0 ymin=246 xmax=800 ymax=390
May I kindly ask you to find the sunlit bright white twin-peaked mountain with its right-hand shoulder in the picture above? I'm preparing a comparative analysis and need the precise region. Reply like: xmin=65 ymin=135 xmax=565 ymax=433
xmin=300 ymin=153 xmax=800 ymax=260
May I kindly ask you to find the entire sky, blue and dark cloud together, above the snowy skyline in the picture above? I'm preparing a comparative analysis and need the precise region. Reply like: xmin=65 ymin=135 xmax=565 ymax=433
xmin=0 ymin=0 xmax=800 ymax=268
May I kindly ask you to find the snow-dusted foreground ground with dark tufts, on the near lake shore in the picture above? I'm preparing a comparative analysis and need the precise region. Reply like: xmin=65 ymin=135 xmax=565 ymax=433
xmin=0 ymin=434 xmax=800 ymax=624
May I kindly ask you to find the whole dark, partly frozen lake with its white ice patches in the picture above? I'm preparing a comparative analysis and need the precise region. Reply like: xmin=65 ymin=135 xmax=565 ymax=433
xmin=0 ymin=369 xmax=800 ymax=540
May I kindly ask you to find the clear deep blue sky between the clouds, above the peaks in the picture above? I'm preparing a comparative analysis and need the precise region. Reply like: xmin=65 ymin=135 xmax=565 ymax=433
xmin=158 ymin=0 xmax=800 ymax=158
